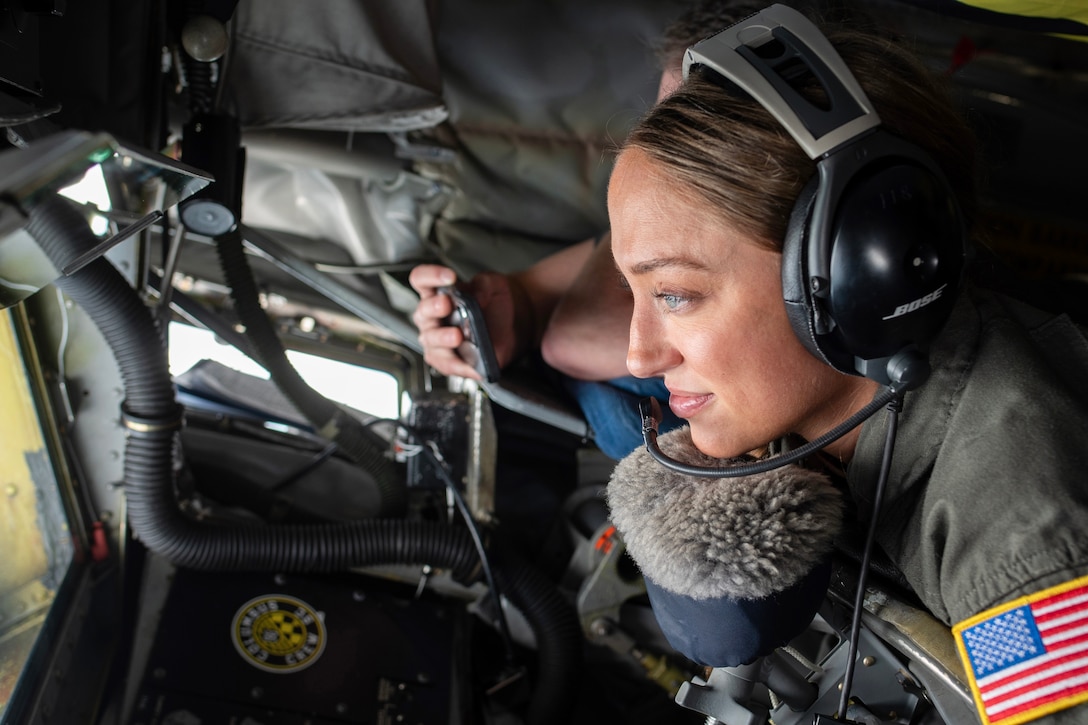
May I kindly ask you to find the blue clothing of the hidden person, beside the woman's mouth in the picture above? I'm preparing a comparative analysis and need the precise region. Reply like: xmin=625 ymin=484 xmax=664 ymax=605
xmin=561 ymin=376 xmax=683 ymax=460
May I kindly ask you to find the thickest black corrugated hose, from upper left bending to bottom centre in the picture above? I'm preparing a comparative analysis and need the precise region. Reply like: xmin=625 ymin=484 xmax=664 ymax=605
xmin=26 ymin=197 xmax=581 ymax=724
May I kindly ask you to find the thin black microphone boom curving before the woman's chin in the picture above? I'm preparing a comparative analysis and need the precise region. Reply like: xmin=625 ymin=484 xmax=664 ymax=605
xmin=639 ymin=388 xmax=903 ymax=478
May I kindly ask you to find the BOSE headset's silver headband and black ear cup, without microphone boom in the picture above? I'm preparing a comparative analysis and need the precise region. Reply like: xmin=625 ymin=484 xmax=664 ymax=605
xmin=683 ymin=4 xmax=966 ymax=388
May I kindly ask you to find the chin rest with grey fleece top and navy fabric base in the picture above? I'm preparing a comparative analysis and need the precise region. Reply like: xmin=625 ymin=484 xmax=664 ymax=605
xmin=606 ymin=428 xmax=843 ymax=667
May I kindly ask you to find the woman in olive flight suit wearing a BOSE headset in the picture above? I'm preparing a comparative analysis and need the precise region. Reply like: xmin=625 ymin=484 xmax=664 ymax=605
xmin=608 ymin=7 xmax=1088 ymax=723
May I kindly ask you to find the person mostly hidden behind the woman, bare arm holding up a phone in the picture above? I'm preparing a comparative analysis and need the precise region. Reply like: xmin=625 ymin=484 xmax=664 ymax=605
xmin=409 ymin=0 xmax=783 ymax=459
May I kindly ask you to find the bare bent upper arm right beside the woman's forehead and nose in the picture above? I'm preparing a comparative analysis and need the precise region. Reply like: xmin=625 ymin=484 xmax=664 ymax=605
xmin=541 ymin=229 xmax=631 ymax=380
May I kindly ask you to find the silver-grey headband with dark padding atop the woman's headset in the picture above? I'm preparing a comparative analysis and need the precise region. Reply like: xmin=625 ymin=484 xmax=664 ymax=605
xmin=683 ymin=4 xmax=880 ymax=160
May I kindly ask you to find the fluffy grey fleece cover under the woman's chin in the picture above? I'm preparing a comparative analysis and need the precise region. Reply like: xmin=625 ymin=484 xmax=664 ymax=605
xmin=607 ymin=427 xmax=842 ymax=599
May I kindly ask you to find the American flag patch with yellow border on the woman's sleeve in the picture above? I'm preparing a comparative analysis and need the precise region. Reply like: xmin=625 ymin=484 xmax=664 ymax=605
xmin=952 ymin=577 xmax=1088 ymax=725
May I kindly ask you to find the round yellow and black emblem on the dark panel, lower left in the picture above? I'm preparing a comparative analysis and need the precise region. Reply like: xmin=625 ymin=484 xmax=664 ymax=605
xmin=231 ymin=594 xmax=325 ymax=673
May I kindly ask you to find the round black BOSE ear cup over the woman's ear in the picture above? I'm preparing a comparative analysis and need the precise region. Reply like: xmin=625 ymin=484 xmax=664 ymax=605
xmin=782 ymin=157 xmax=966 ymax=382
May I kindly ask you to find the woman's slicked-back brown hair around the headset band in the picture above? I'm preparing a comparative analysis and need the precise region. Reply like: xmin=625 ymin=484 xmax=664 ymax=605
xmin=625 ymin=21 xmax=975 ymax=249
